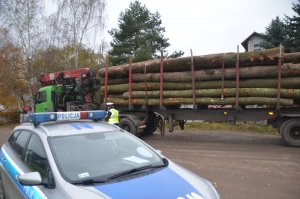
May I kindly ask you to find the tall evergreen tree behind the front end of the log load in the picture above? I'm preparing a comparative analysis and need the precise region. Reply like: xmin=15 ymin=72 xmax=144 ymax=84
xmin=109 ymin=1 xmax=170 ymax=65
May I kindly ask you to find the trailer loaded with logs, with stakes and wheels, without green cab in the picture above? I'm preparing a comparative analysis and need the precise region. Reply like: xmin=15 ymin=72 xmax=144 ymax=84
xmin=34 ymin=48 xmax=300 ymax=147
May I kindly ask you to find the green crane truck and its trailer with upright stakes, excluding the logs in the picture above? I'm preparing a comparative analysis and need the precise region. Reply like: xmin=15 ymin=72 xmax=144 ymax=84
xmin=35 ymin=47 xmax=300 ymax=147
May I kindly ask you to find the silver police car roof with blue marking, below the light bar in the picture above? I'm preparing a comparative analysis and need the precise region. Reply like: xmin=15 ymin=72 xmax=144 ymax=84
xmin=15 ymin=120 xmax=121 ymax=136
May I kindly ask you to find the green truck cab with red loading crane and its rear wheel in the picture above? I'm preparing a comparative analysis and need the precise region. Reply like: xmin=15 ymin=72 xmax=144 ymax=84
xmin=35 ymin=68 xmax=149 ymax=135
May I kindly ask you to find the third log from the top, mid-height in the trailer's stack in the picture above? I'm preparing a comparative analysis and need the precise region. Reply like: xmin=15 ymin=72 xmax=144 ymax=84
xmin=101 ymin=77 xmax=300 ymax=94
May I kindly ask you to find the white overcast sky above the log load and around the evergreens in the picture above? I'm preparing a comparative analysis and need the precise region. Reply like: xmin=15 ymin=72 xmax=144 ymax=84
xmin=104 ymin=0 xmax=296 ymax=56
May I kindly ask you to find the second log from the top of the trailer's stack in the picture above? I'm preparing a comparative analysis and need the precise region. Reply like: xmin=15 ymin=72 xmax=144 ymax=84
xmin=132 ymin=63 xmax=300 ymax=82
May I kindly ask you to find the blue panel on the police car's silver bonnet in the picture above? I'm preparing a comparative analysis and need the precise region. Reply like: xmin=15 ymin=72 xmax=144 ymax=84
xmin=95 ymin=168 xmax=204 ymax=199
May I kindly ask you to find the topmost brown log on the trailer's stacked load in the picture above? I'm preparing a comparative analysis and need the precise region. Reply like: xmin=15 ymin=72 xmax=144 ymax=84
xmin=99 ymin=48 xmax=300 ymax=78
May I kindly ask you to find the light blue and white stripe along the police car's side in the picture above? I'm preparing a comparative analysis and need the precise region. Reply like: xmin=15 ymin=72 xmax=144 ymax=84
xmin=0 ymin=149 xmax=47 ymax=199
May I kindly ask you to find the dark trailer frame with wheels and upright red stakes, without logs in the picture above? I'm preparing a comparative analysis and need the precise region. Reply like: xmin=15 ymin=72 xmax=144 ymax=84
xmin=102 ymin=47 xmax=300 ymax=147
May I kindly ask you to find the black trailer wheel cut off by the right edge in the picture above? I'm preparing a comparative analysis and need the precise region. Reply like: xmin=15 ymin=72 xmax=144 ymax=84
xmin=280 ymin=118 xmax=300 ymax=147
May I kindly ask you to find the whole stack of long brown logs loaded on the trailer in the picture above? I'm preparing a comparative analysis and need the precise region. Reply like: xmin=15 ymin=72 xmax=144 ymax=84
xmin=99 ymin=48 xmax=300 ymax=107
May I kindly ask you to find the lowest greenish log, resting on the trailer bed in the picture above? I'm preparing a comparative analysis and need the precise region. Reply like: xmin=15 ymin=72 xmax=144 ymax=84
xmin=108 ymin=97 xmax=293 ymax=106
